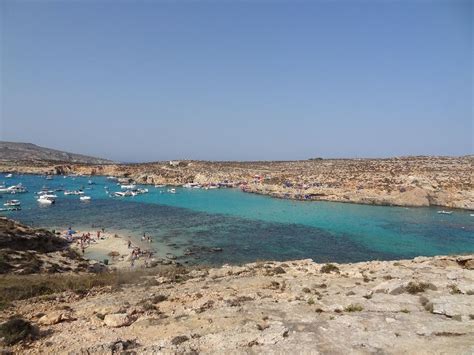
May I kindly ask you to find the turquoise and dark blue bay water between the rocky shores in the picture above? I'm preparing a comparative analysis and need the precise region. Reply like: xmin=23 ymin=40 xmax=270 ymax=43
xmin=0 ymin=175 xmax=474 ymax=264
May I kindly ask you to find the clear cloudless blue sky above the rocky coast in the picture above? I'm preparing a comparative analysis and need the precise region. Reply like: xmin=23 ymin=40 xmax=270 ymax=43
xmin=0 ymin=0 xmax=474 ymax=162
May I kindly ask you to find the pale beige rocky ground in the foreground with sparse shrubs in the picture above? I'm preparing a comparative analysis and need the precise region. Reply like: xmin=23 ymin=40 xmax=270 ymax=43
xmin=0 ymin=255 xmax=474 ymax=354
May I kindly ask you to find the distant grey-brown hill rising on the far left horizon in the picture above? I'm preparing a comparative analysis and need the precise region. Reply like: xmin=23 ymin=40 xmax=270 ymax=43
xmin=0 ymin=142 xmax=112 ymax=164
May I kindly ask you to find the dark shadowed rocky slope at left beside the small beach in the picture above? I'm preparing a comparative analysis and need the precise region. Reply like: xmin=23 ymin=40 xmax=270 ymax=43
xmin=0 ymin=217 xmax=89 ymax=275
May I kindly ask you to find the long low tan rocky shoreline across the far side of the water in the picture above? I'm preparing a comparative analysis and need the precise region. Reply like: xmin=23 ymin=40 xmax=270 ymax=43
xmin=0 ymin=156 xmax=474 ymax=210
